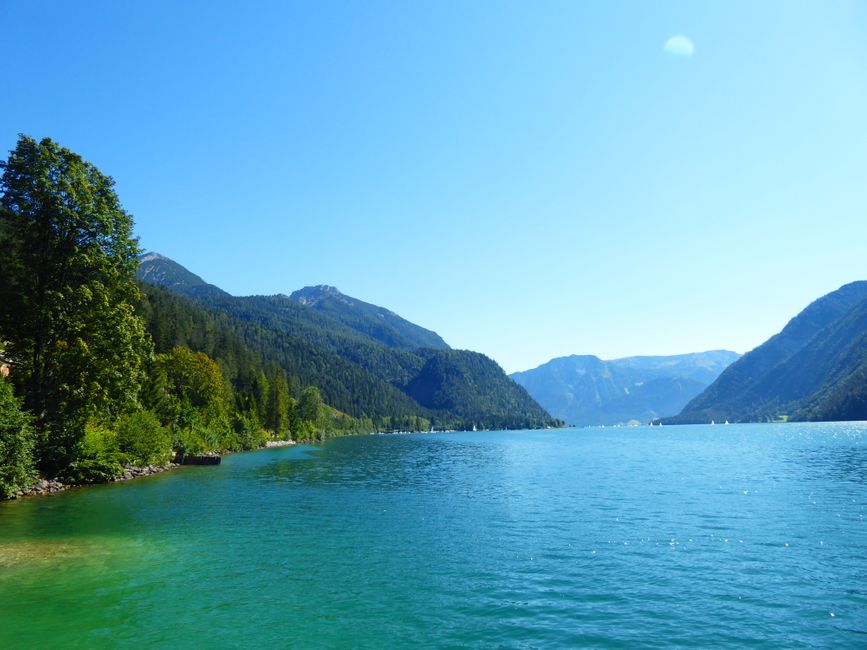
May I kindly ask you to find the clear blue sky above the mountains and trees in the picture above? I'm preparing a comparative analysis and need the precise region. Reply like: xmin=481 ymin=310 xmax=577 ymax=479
xmin=0 ymin=0 xmax=867 ymax=372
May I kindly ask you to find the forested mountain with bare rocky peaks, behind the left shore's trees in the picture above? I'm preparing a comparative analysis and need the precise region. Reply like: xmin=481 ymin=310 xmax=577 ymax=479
xmin=138 ymin=253 xmax=556 ymax=428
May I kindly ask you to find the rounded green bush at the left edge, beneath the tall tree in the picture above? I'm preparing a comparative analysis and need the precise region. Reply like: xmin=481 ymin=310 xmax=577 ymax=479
xmin=0 ymin=377 xmax=33 ymax=499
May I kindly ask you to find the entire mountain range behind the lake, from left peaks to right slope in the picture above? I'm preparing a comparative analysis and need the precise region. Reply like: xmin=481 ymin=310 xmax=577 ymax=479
xmin=138 ymin=253 xmax=867 ymax=428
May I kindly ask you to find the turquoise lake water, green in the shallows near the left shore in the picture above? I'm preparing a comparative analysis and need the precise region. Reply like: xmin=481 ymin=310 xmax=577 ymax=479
xmin=0 ymin=423 xmax=867 ymax=648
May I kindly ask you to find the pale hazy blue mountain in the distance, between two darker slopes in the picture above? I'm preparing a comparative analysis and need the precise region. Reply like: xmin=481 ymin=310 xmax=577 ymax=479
xmin=511 ymin=350 xmax=739 ymax=426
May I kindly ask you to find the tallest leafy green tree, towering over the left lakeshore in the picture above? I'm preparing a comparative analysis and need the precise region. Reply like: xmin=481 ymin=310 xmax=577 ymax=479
xmin=0 ymin=136 xmax=150 ymax=474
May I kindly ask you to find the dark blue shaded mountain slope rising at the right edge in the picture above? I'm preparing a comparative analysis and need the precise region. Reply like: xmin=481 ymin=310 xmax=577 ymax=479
xmin=668 ymin=281 xmax=867 ymax=423
